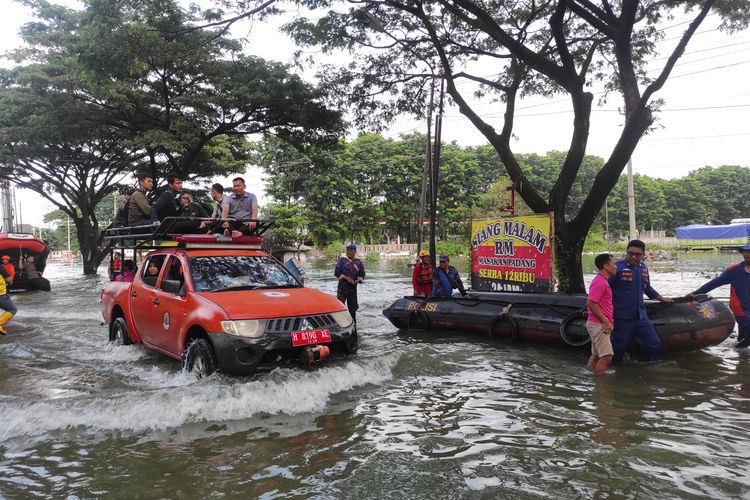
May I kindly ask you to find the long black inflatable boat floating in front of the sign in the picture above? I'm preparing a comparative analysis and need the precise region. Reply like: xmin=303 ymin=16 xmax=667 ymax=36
xmin=383 ymin=292 xmax=734 ymax=352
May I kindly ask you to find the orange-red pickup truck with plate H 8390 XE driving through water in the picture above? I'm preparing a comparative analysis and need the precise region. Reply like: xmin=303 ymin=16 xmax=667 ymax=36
xmin=101 ymin=238 xmax=357 ymax=377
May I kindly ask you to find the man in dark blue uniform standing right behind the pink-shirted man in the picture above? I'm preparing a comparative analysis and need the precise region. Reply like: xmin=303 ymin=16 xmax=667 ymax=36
xmin=609 ymin=240 xmax=672 ymax=363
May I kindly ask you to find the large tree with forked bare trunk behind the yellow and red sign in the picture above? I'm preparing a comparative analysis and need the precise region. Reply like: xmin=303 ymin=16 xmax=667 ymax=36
xmin=278 ymin=0 xmax=750 ymax=292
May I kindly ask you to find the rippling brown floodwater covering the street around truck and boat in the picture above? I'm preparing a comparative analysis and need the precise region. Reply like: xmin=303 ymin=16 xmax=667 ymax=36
xmin=0 ymin=255 xmax=750 ymax=499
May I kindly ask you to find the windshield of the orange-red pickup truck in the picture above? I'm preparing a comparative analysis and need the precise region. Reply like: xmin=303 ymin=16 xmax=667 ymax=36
xmin=189 ymin=255 xmax=300 ymax=292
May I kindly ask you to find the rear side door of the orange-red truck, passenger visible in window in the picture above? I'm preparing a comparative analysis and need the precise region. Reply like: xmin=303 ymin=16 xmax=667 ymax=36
xmin=130 ymin=255 xmax=167 ymax=346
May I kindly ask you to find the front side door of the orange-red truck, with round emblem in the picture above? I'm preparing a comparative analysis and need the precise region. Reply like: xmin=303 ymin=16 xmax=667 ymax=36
xmin=147 ymin=255 xmax=187 ymax=356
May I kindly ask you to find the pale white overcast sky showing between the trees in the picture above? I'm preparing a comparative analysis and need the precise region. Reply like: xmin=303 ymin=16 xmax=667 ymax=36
xmin=0 ymin=0 xmax=750 ymax=225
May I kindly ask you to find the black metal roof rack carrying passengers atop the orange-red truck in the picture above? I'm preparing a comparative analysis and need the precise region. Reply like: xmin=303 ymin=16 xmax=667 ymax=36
xmin=103 ymin=217 xmax=275 ymax=250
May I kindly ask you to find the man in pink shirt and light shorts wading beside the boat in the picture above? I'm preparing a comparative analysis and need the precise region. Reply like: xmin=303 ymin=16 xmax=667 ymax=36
xmin=586 ymin=253 xmax=617 ymax=374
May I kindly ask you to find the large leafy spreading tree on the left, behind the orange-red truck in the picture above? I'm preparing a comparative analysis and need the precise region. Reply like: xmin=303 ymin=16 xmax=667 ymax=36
xmin=0 ymin=0 xmax=342 ymax=274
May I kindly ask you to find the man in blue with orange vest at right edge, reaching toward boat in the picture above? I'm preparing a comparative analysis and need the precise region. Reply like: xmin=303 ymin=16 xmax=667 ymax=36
xmin=693 ymin=243 xmax=750 ymax=348
